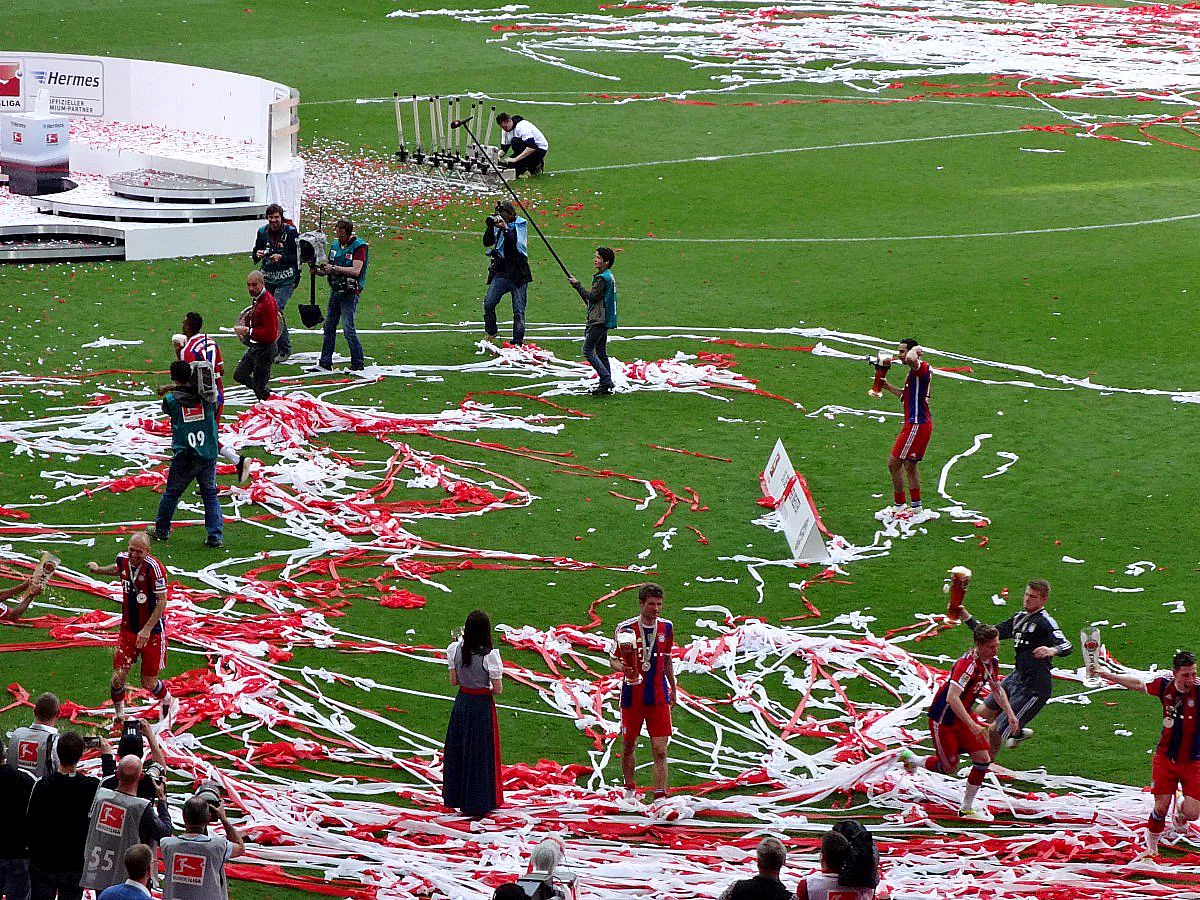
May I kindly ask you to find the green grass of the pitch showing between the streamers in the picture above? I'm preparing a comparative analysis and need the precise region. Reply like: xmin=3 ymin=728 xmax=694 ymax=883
xmin=0 ymin=0 xmax=1200 ymax=898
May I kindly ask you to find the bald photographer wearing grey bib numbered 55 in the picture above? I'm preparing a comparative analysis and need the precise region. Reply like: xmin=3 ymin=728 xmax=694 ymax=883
xmin=79 ymin=756 xmax=174 ymax=893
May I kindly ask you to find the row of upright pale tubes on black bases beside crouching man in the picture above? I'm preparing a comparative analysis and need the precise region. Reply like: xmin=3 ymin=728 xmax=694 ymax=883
xmin=392 ymin=91 xmax=508 ymax=190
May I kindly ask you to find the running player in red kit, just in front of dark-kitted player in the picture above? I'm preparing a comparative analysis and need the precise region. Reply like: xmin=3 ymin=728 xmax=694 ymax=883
xmin=900 ymin=625 xmax=1021 ymax=817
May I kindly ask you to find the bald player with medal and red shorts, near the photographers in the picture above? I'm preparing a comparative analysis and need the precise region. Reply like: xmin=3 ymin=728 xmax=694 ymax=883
xmin=88 ymin=532 xmax=173 ymax=721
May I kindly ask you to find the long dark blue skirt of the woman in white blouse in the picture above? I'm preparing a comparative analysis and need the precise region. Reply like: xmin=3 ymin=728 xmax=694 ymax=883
xmin=442 ymin=688 xmax=504 ymax=816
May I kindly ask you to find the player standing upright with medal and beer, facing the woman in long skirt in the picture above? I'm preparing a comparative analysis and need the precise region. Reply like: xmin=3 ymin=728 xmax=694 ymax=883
xmin=613 ymin=582 xmax=678 ymax=799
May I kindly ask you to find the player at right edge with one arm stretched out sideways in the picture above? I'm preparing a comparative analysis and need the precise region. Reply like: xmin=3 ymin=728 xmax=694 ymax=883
xmin=1098 ymin=650 xmax=1200 ymax=854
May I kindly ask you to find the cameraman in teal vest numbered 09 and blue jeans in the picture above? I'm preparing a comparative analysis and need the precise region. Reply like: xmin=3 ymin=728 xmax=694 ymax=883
xmin=151 ymin=360 xmax=223 ymax=547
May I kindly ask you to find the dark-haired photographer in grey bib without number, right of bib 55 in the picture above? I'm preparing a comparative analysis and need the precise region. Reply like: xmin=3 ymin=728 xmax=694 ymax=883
xmin=162 ymin=782 xmax=246 ymax=900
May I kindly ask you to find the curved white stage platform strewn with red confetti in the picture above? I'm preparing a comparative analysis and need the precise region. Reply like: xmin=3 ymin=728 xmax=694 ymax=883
xmin=0 ymin=50 xmax=304 ymax=262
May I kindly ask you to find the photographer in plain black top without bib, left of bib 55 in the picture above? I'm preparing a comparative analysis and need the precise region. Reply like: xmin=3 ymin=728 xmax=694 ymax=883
xmin=29 ymin=731 xmax=113 ymax=900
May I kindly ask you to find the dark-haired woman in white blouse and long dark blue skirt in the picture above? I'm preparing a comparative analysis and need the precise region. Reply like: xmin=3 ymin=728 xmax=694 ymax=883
xmin=442 ymin=610 xmax=504 ymax=818
